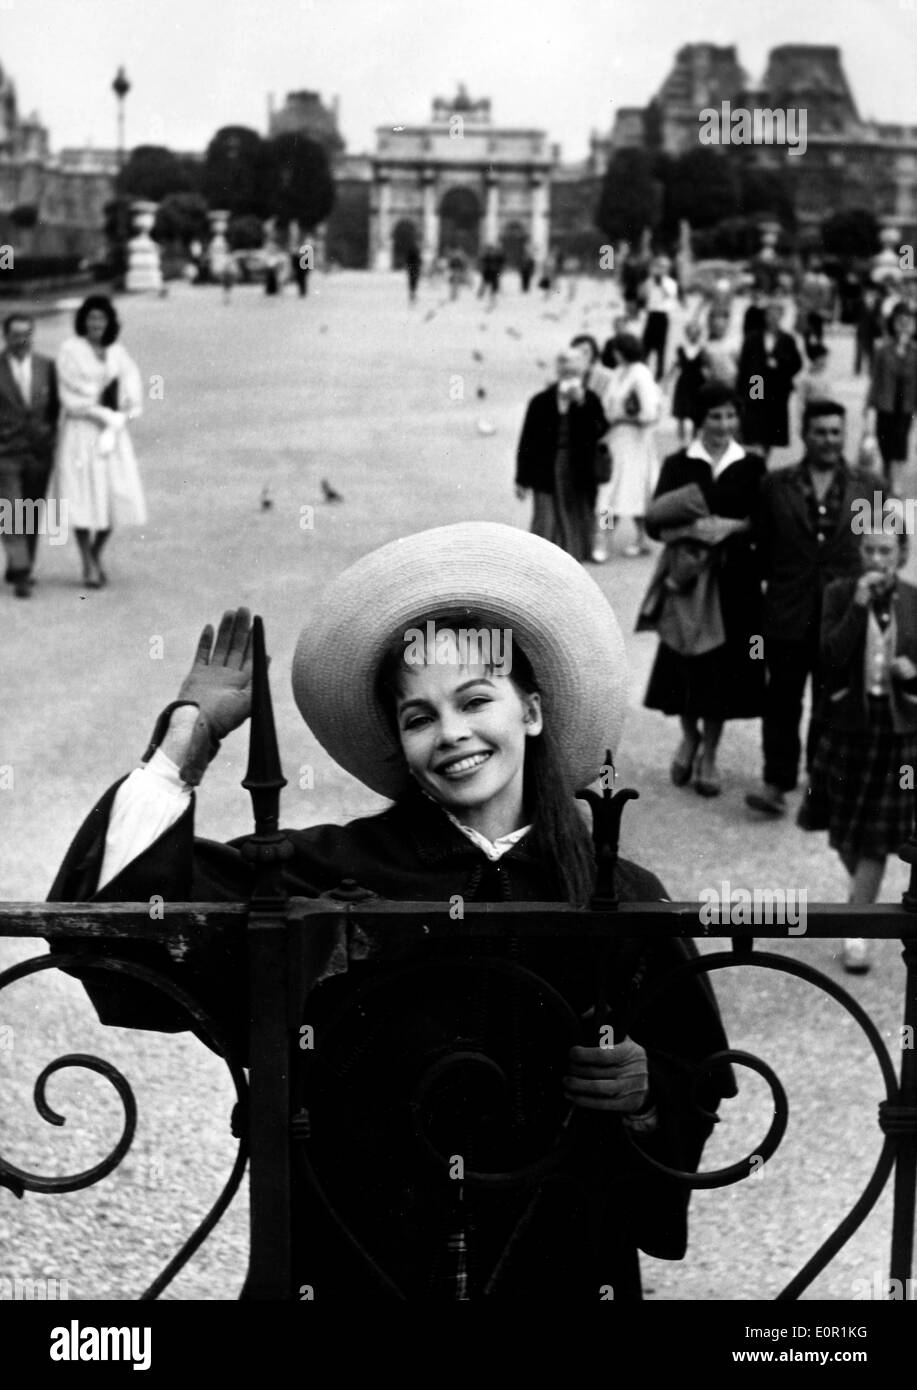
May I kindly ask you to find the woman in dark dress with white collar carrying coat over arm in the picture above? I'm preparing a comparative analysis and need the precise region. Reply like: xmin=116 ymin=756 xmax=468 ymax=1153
xmin=643 ymin=385 xmax=766 ymax=796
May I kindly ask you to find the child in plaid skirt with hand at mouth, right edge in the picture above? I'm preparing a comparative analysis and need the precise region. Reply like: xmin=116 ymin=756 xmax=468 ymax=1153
xmin=799 ymin=500 xmax=917 ymax=973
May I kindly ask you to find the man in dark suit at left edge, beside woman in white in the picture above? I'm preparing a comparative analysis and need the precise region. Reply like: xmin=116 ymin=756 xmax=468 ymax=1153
xmin=0 ymin=313 xmax=58 ymax=599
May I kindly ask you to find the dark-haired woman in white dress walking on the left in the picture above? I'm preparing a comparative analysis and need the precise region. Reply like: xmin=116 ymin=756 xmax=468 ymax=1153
xmin=54 ymin=295 xmax=146 ymax=589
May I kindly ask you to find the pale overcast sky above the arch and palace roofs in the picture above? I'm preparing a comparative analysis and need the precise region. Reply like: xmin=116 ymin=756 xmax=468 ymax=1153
xmin=0 ymin=0 xmax=917 ymax=160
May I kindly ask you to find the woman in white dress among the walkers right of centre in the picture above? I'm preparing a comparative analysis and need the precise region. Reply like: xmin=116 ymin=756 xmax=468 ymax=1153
xmin=593 ymin=334 xmax=660 ymax=562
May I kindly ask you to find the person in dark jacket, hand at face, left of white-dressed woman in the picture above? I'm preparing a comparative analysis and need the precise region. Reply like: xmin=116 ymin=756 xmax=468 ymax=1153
xmin=515 ymin=348 xmax=609 ymax=560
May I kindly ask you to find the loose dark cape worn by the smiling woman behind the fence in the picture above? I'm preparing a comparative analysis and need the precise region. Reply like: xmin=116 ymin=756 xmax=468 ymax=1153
xmin=50 ymin=784 xmax=735 ymax=1304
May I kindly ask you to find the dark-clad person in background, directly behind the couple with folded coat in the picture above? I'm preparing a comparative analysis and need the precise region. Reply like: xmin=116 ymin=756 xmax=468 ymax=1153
xmin=735 ymin=300 xmax=803 ymax=459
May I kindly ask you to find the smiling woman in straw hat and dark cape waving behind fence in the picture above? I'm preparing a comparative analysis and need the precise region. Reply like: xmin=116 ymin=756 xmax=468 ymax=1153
xmin=53 ymin=523 xmax=734 ymax=1305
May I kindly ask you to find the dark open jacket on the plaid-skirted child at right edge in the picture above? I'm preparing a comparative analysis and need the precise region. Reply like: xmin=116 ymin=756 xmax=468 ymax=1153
xmin=821 ymin=578 xmax=917 ymax=734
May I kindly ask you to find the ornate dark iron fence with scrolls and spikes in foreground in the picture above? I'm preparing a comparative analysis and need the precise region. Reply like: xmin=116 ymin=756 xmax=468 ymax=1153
xmin=0 ymin=620 xmax=917 ymax=1300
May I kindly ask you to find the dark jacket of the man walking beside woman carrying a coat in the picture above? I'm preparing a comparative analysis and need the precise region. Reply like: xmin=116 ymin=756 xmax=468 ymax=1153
xmin=756 ymin=463 xmax=875 ymax=642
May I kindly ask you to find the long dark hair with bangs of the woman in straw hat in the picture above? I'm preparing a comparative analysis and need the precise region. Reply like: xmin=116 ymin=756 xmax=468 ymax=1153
xmin=377 ymin=613 xmax=596 ymax=908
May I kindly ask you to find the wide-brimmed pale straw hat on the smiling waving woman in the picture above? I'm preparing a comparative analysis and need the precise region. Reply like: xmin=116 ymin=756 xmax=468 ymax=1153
xmin=293 ymin=521 xmax=628 ymax=799
